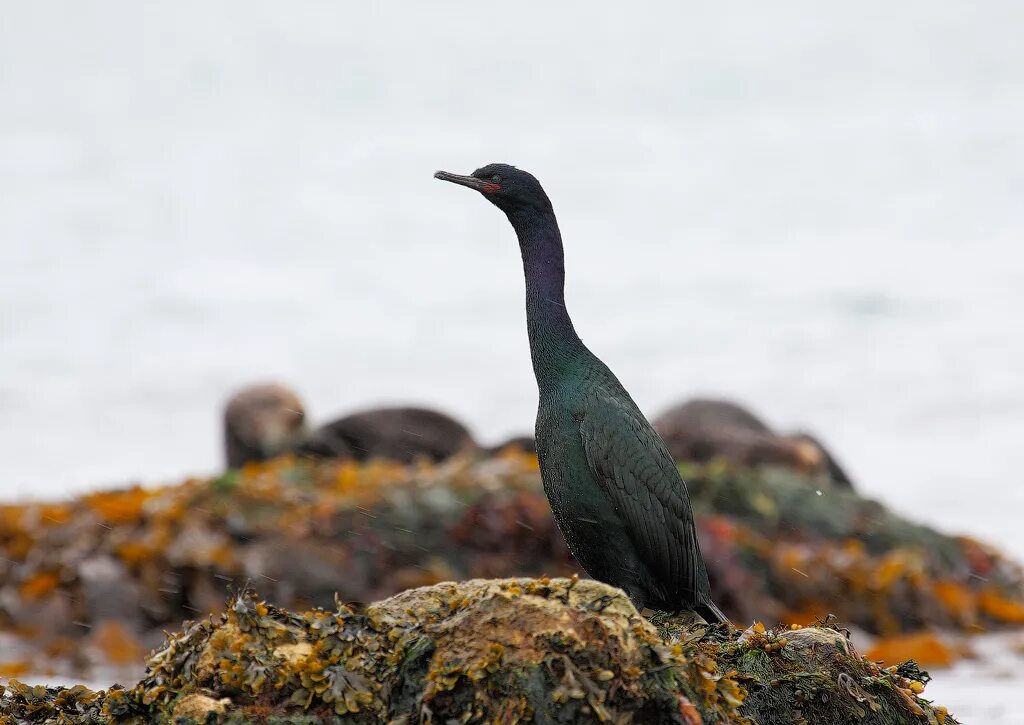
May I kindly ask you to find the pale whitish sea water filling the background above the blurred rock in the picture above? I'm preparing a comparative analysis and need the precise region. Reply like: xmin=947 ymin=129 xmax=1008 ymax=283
xmin=0 ymin=5 xmax=1024 ymax=544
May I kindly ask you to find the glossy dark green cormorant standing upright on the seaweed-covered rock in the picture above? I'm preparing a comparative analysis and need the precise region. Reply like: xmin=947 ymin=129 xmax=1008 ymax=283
xmin=434 ymin=164 xmax=727 ymax=623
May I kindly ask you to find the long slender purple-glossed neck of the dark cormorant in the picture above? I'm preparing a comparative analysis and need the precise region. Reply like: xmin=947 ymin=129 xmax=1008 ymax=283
xmin=508 ymin=209 xmax=587 ymax=388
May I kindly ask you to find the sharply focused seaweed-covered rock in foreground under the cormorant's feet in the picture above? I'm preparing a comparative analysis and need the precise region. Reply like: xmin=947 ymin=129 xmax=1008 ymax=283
xmin=0 ymin=579 xmax=955 ymax=725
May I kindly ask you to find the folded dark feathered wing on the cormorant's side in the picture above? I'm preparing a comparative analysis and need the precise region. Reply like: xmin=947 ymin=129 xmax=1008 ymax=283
xmin=580 ymin=391 xmax=708 ymax=605
